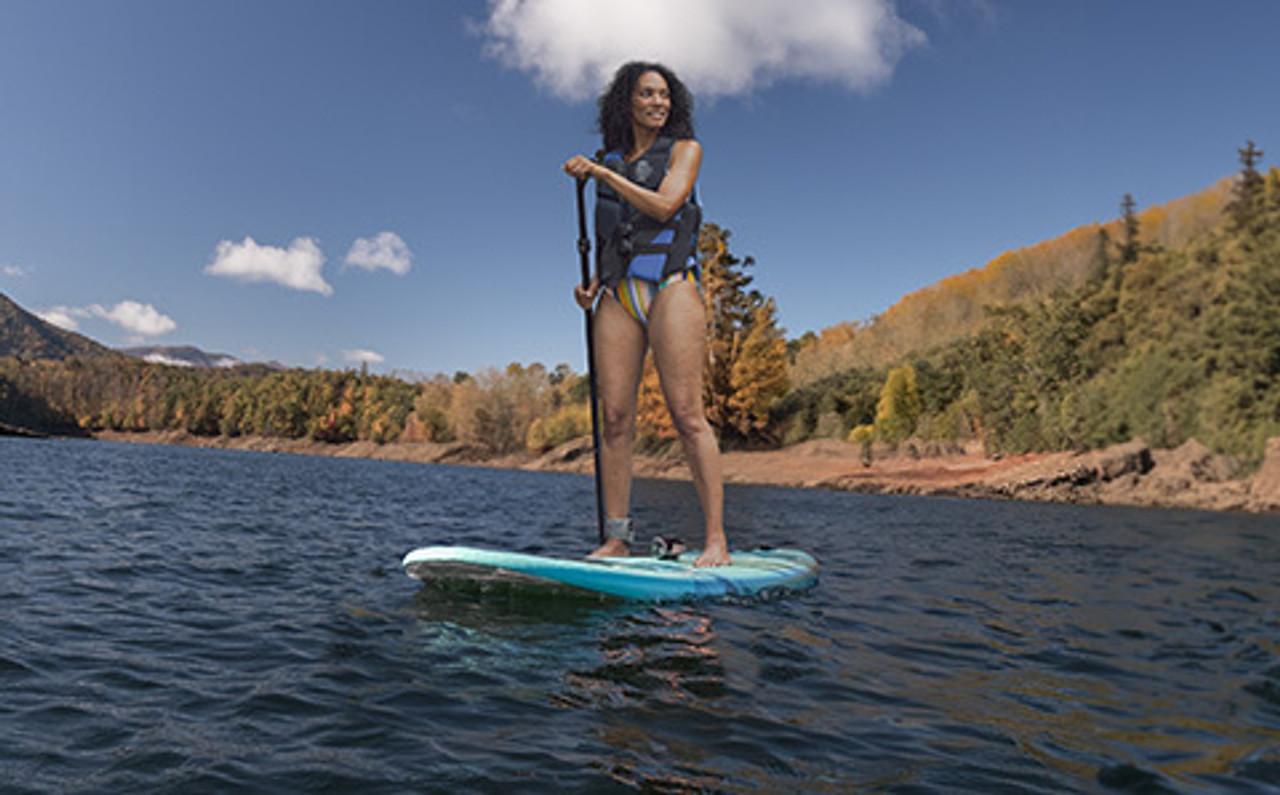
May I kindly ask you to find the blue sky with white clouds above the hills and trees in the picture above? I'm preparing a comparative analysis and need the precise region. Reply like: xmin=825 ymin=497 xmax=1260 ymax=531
xmin=0 ymin=0 xmax=1280 ymax=374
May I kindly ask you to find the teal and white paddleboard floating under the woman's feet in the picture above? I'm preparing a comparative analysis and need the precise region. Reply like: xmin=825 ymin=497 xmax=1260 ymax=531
xmin=403 ymin=547 xmax=818 ymax=602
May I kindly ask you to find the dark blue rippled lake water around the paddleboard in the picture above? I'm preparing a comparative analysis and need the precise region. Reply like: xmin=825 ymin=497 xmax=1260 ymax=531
xmin=0 ymin=439 xmax=1280 ymax=792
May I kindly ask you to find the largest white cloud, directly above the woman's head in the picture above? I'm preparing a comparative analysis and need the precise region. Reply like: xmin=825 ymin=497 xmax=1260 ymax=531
xmin=481 ymin=0 xmax=925 ymax=100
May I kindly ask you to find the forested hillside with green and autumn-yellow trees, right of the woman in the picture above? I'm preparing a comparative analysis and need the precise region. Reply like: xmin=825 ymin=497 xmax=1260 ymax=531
xmin=777 ymin=142 xmax=1280 ymax=470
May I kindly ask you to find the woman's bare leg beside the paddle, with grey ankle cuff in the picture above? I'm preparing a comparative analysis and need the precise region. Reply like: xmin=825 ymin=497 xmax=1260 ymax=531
xmin=589 ymin=296 xmax=648 ymax=557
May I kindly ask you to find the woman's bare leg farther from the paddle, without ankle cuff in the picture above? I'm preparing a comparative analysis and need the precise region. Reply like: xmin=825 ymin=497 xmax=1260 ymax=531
xmin=649 ymin=282 xmax=732 ymax=566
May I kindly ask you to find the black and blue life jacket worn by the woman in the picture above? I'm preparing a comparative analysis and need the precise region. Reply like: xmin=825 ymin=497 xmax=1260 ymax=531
xmin=595 ymin=136 xmax=703 ymax=287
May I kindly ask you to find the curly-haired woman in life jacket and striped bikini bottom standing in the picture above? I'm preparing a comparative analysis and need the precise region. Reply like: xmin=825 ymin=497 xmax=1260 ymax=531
xmin=564 ymin=63 xmax=732 ymax=566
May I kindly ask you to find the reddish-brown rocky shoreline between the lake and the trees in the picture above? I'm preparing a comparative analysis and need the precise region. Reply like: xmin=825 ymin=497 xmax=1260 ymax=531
xmin=95 ymin=431 xmax=1280 ymax=512
